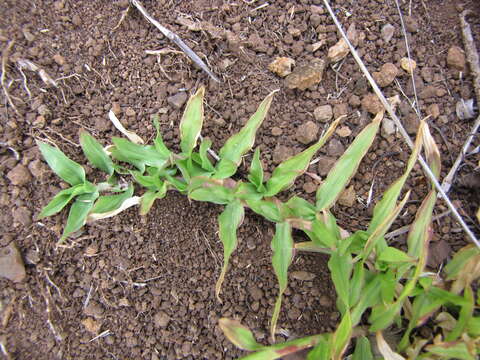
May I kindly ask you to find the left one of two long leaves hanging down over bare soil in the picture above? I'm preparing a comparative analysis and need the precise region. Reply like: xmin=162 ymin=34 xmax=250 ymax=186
xmin=215 ymin=200 xmax=244 ymax=302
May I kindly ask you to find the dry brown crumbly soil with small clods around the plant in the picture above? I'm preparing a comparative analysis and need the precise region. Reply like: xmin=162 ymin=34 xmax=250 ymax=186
xmin=0 ymin=0 xmax=480 ymax=360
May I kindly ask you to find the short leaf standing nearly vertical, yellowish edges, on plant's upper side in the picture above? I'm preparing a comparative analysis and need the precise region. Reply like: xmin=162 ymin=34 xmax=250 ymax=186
xmin=180 ymin=86 xmax=205 ymax=156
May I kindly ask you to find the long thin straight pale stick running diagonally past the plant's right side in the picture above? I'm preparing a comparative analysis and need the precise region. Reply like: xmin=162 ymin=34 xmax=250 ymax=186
xmin=323 ymin=0 xmax=480 ymax=248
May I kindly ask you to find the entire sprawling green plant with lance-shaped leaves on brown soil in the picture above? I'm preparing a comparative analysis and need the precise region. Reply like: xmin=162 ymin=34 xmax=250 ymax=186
xmin=38 ymin=88 xmax=480 ymax=359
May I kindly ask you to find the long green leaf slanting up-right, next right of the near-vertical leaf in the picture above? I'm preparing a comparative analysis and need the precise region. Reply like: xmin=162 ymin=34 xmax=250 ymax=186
xmin=215 ymin=90 xmax=277 ymax=179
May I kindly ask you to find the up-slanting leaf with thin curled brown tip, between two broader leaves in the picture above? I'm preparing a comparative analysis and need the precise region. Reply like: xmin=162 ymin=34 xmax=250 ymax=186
xmin=265 ymin=117 xmax=343 ymax=196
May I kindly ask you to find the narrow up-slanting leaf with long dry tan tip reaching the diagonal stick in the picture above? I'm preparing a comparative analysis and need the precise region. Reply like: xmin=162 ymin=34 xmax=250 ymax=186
xmin=367 ymin=122 xmax=425 ymax=234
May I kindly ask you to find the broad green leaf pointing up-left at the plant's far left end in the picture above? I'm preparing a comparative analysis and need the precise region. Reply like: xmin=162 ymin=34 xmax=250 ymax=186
xmin=37 ymin=140 xmax=85 ymax=185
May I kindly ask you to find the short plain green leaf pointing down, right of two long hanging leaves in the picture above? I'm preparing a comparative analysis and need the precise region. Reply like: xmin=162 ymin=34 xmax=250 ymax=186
xmin=328 ymin=251 xmax=353 ymax=309
